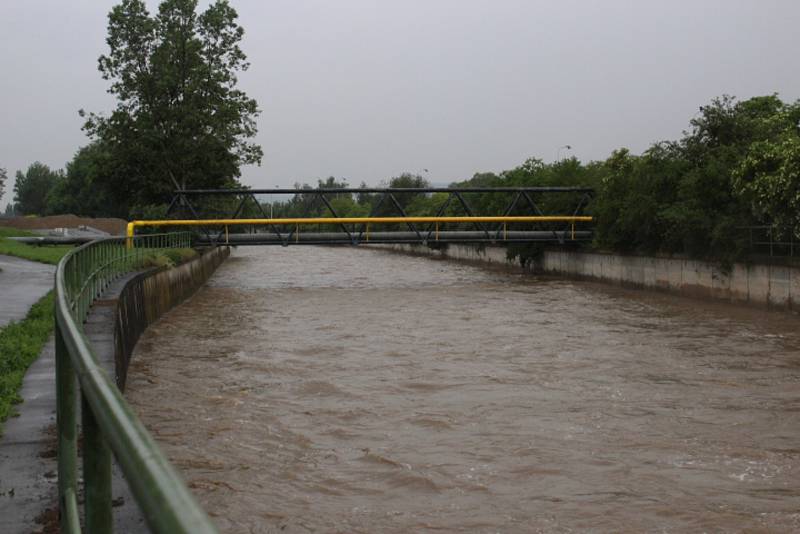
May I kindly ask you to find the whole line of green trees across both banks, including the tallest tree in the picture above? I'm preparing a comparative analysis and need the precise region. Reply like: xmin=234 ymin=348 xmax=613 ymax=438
xmin=0 ymin=0 xmax=800 ymax=268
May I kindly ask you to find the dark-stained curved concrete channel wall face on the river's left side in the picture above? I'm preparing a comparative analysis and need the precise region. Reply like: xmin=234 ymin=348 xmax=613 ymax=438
xmin=114 ymin=247 xmax=230 ymax=390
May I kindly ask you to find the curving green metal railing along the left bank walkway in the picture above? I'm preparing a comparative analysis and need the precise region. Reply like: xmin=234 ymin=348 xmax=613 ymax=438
xmin=55 ymin=233 xmax=216 ymax=534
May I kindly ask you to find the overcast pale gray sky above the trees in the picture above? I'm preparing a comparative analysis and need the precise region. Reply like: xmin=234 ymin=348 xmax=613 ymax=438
xmin=0 ymin=0 xmax=800 ymax=207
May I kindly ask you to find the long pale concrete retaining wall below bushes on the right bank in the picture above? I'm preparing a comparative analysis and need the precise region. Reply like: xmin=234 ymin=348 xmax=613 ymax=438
xmin=369 ymin=244 xmax=800 ymax=313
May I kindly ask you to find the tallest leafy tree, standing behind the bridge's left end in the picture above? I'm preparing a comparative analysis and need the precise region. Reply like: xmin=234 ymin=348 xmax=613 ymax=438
xmin=81 ymin=0 xmax=262 ymax=216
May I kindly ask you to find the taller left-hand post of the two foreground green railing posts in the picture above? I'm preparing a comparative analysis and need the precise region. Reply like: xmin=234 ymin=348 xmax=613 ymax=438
xmin=55 ymin=321 xmax=79 ymax=533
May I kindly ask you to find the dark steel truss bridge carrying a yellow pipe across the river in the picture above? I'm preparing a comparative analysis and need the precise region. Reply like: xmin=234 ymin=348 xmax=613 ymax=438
xmin=127 ymin=187 xmax=594 ymax=246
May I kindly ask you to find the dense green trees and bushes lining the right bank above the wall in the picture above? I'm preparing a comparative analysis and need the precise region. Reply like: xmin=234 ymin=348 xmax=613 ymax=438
xmin=446 ymin=95 xmax=800 ymax=265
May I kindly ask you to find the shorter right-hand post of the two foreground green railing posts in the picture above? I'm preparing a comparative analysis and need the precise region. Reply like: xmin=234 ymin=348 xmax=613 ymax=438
xmin=81 ymin=395 xmax=113 ymax=533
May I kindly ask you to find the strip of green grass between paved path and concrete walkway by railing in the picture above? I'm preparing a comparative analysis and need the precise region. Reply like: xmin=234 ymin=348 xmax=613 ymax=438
xmin=0 ymin=291 xmax=53 ymax=434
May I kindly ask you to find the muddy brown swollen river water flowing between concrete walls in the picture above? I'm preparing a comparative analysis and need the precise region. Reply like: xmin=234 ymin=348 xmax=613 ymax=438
xmin=127 ymin=246 xmax=800 ymax=532
